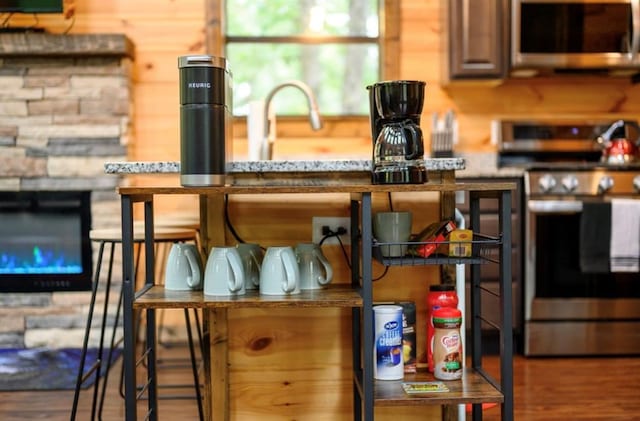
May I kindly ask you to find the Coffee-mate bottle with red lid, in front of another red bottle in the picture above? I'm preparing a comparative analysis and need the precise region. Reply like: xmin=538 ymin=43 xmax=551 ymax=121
xmin=433 ymin=307 xmax=463 ymax=380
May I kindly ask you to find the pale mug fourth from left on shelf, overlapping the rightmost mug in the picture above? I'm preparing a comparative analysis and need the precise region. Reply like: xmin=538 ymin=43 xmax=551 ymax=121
xmin=260 ymin=246 xmax=300 ymax=295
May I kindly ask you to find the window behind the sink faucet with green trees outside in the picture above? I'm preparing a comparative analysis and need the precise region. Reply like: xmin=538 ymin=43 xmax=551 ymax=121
xmin=216 ymin=0 xmax=396 ymax=116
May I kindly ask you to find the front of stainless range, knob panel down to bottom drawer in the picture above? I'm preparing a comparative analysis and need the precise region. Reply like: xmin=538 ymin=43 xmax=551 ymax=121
xmin=524 ymin=167 xmax=640 ymax=355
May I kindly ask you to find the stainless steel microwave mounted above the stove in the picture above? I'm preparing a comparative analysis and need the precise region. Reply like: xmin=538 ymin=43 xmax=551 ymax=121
xmin=511 ymin=0 xmax=640 ymax=70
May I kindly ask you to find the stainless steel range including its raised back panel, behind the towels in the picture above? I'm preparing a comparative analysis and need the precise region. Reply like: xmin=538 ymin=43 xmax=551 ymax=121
xmin=498 ymin=119 xmax=640 ymax=356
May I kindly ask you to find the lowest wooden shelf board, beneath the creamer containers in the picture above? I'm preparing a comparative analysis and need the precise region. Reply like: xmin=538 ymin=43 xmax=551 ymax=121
xmin=374 ymin=367 xmax=504 ymax=406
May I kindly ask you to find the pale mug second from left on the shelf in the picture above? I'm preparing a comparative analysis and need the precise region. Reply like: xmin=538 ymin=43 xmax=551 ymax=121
xmin=204 ymin=247 xmax=245 ymax=296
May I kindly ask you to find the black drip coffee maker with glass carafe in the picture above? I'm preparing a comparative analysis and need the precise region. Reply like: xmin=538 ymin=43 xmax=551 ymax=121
xmin=367 ymin=80 xmax=427 ymax=184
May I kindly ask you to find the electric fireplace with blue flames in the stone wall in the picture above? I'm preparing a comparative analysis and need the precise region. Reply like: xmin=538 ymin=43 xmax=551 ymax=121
xmin=0 ymin=191 xmax=92 ymax=292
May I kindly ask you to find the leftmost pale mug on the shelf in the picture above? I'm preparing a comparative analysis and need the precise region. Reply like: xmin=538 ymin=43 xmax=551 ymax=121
xmin=164 ymin=243 xmax=202 ymax=291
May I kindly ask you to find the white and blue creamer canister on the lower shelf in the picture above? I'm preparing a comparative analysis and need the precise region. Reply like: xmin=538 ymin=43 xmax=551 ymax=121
xmin=373 ymin=305 xmax=404 ymax=380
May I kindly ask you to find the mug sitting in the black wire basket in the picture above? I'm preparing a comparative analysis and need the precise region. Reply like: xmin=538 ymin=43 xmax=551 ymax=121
xmin=373 ymin=212 xmax=412 ymax=257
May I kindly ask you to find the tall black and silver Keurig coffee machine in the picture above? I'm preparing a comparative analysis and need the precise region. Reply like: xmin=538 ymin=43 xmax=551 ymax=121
xmin=178 ymin=55 xmax=232 ymax=186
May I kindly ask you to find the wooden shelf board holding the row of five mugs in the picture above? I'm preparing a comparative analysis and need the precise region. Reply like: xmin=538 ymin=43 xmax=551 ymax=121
xmin=133 ymin=285 xmax=362 ymax=309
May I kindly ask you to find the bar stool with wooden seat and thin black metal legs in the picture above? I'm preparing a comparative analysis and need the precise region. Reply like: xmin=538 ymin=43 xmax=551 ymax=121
xmin=71 ymin=227 xmax=204 ymax=421
